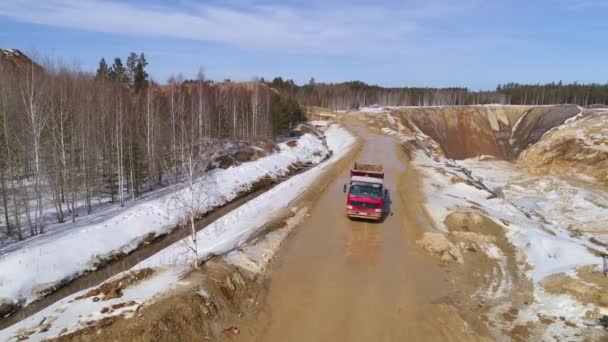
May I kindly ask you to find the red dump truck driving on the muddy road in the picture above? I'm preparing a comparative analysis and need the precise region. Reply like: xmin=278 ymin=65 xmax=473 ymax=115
xmin=344 ymin=162 xmax=384 ymax=221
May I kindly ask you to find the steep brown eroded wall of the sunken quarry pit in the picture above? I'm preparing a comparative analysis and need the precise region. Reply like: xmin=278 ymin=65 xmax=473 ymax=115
xmin=392 ymin=106 xmax=580 ymax=160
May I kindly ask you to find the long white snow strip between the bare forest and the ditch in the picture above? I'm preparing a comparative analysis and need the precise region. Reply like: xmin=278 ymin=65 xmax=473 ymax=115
xmin=0 ymin=132 xmax=332 ymax=303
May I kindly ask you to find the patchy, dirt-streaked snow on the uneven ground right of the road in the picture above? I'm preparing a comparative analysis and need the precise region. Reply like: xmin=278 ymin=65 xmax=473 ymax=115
xmin=383 ymin=123 xmax=608 ymax=339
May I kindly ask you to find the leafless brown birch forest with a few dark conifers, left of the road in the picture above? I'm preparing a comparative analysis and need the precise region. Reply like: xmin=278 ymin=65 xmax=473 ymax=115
xmin=0 ymin=53 xmax=304 ymax=239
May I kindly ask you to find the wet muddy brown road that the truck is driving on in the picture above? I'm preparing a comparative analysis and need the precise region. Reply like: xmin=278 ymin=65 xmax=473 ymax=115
xmin=239 ymin=119 xmax=490 ymax=341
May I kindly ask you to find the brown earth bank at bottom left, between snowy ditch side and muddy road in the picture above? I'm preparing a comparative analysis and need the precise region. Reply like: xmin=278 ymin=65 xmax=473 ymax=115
xmin=56 ymin=259 xmax=263 ymax=341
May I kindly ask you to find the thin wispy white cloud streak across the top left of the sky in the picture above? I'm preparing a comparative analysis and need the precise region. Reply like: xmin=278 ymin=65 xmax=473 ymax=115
xmin=0 ymin=0 xmax=460 ymax=53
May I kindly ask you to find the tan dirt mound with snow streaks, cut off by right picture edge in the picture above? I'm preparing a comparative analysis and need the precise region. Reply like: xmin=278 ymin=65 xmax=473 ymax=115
xmin=519 ymin=110 xmax=608 ymax=184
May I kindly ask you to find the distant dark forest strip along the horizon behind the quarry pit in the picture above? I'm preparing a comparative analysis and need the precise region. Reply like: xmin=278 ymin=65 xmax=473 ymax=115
xmin=262 ymin=77 xmax=608 ymax=110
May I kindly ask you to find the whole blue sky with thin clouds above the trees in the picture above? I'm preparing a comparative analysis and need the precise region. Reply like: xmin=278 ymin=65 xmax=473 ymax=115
xmin=0 ymin=0 xmax=608 ymax=89
